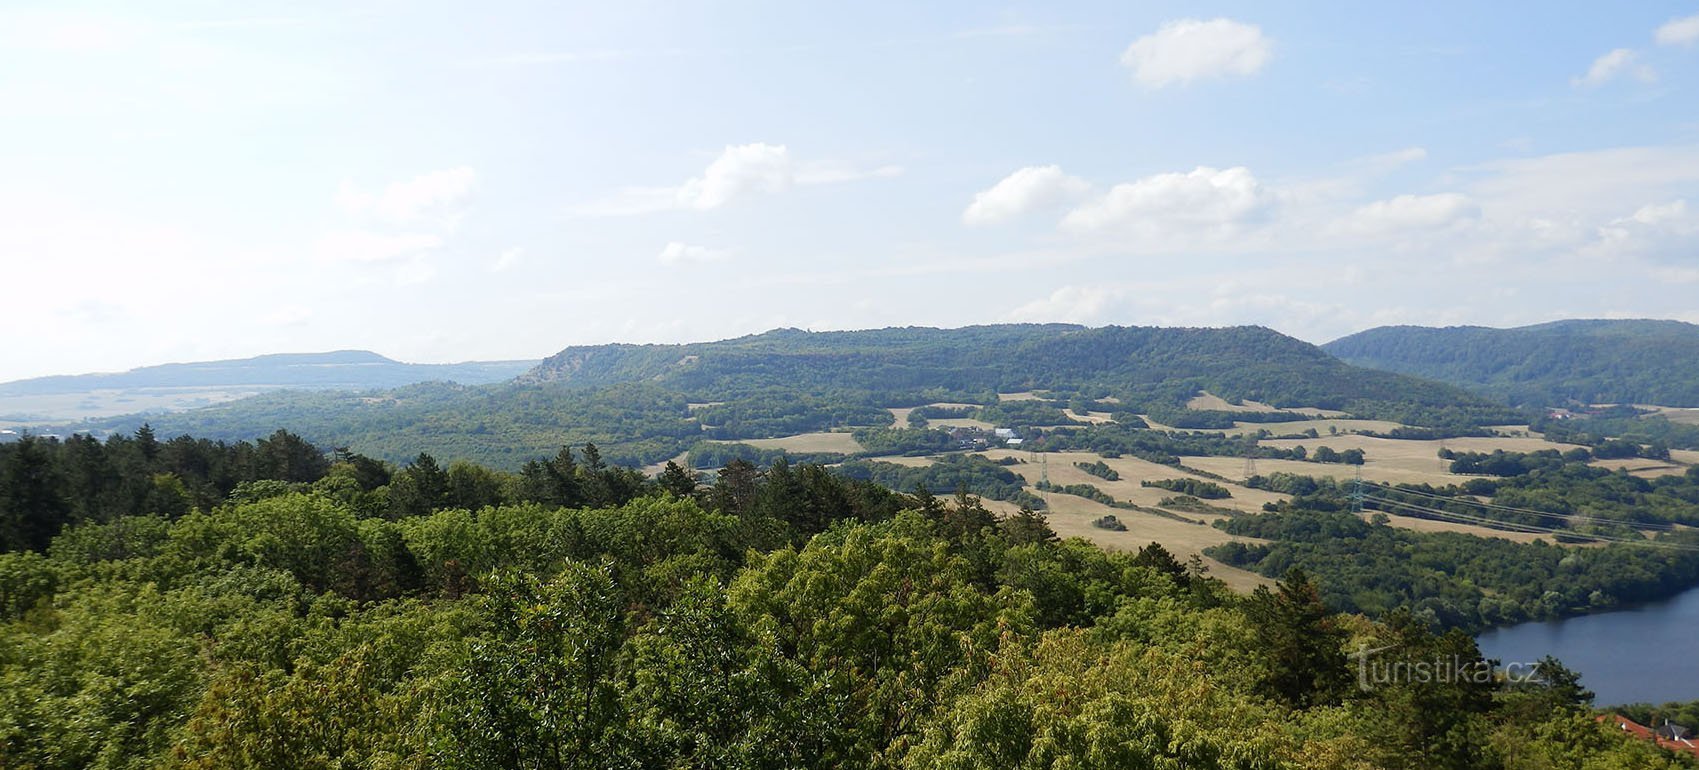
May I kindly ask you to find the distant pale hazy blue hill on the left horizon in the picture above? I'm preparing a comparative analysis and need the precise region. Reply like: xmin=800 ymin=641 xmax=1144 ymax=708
xmin=0 ymin=350 xmax=533 ymax=396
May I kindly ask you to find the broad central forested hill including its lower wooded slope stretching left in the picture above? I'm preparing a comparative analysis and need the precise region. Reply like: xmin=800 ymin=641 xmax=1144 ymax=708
xmin=68 ymin=325 xmax=1517 ymax=467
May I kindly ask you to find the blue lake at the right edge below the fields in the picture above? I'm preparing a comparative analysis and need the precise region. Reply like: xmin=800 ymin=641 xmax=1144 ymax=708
xmin=1476 ymin=588 xmax=1699 ymax=705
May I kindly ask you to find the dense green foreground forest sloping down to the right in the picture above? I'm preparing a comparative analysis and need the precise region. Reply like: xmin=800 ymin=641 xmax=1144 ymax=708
xmin=0 ymin=433 xmax=1696 ymax=770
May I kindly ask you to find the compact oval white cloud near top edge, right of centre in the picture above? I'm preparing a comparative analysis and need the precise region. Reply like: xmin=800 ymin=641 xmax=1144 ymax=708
xmin=1121 ymin=19 xmax=1273 ymax=88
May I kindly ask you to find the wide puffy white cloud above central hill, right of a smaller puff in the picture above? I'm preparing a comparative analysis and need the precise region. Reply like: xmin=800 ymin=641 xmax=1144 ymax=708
xmin=1062 ymin=167 xmax=1276 ymax=238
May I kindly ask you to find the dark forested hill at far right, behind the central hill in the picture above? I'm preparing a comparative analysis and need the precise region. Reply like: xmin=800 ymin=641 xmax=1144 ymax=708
xmin=1324 ymin=320 xmax=1699 ymax=406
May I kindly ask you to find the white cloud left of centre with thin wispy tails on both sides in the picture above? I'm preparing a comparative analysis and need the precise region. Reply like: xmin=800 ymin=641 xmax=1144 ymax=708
xmin=576 ymin=141 xmax=902 ymax=216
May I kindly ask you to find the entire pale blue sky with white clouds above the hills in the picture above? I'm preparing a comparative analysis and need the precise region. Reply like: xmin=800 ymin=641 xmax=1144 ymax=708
xmin=0 ymin=0 xmax=1699 ymax=381
